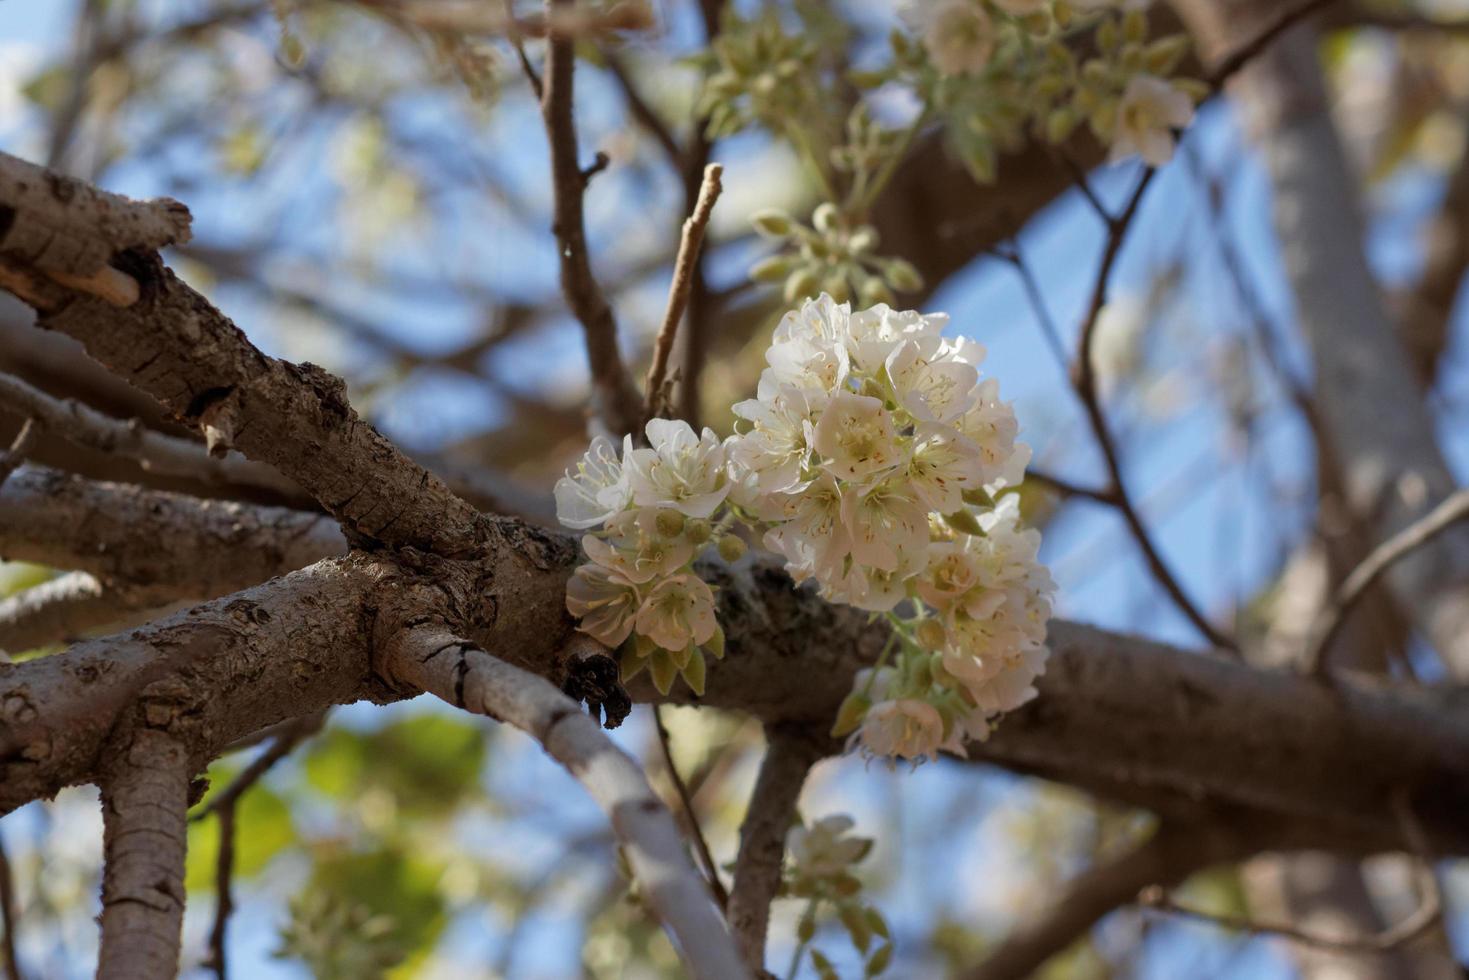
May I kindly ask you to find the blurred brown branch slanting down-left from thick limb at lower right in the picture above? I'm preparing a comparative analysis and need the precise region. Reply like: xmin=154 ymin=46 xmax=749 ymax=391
xmin=964 ymin=823 xmax=1231 ymax=980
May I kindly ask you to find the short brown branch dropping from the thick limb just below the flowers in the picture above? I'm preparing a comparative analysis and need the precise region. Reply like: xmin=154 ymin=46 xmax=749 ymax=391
xmin=729 ymin=727 xmax=823 ymax=970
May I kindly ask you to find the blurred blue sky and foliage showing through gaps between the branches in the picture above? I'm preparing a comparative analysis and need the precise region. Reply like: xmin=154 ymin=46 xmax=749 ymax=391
xmin=0 ymin=0 xmax=1469 ymax=980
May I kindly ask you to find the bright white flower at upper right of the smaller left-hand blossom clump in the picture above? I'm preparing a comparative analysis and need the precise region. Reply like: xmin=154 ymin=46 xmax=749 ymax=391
xmin=623 ymin=419 xmax=730 ymax=517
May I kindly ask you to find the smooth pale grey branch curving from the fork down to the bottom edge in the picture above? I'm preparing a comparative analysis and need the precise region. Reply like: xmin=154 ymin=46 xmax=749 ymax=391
xmin=378 ymin=626 xmax=749 ymax=980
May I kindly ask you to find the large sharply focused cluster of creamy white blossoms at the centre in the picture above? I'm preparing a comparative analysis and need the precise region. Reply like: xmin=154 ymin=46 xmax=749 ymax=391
xmin=555 ymin=295 xmax=1053 ymax=760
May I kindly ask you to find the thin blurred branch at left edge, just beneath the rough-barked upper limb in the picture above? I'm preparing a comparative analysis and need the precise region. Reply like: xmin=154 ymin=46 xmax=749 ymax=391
xmin=0 ymin=375 xmax=301 ymax=497
